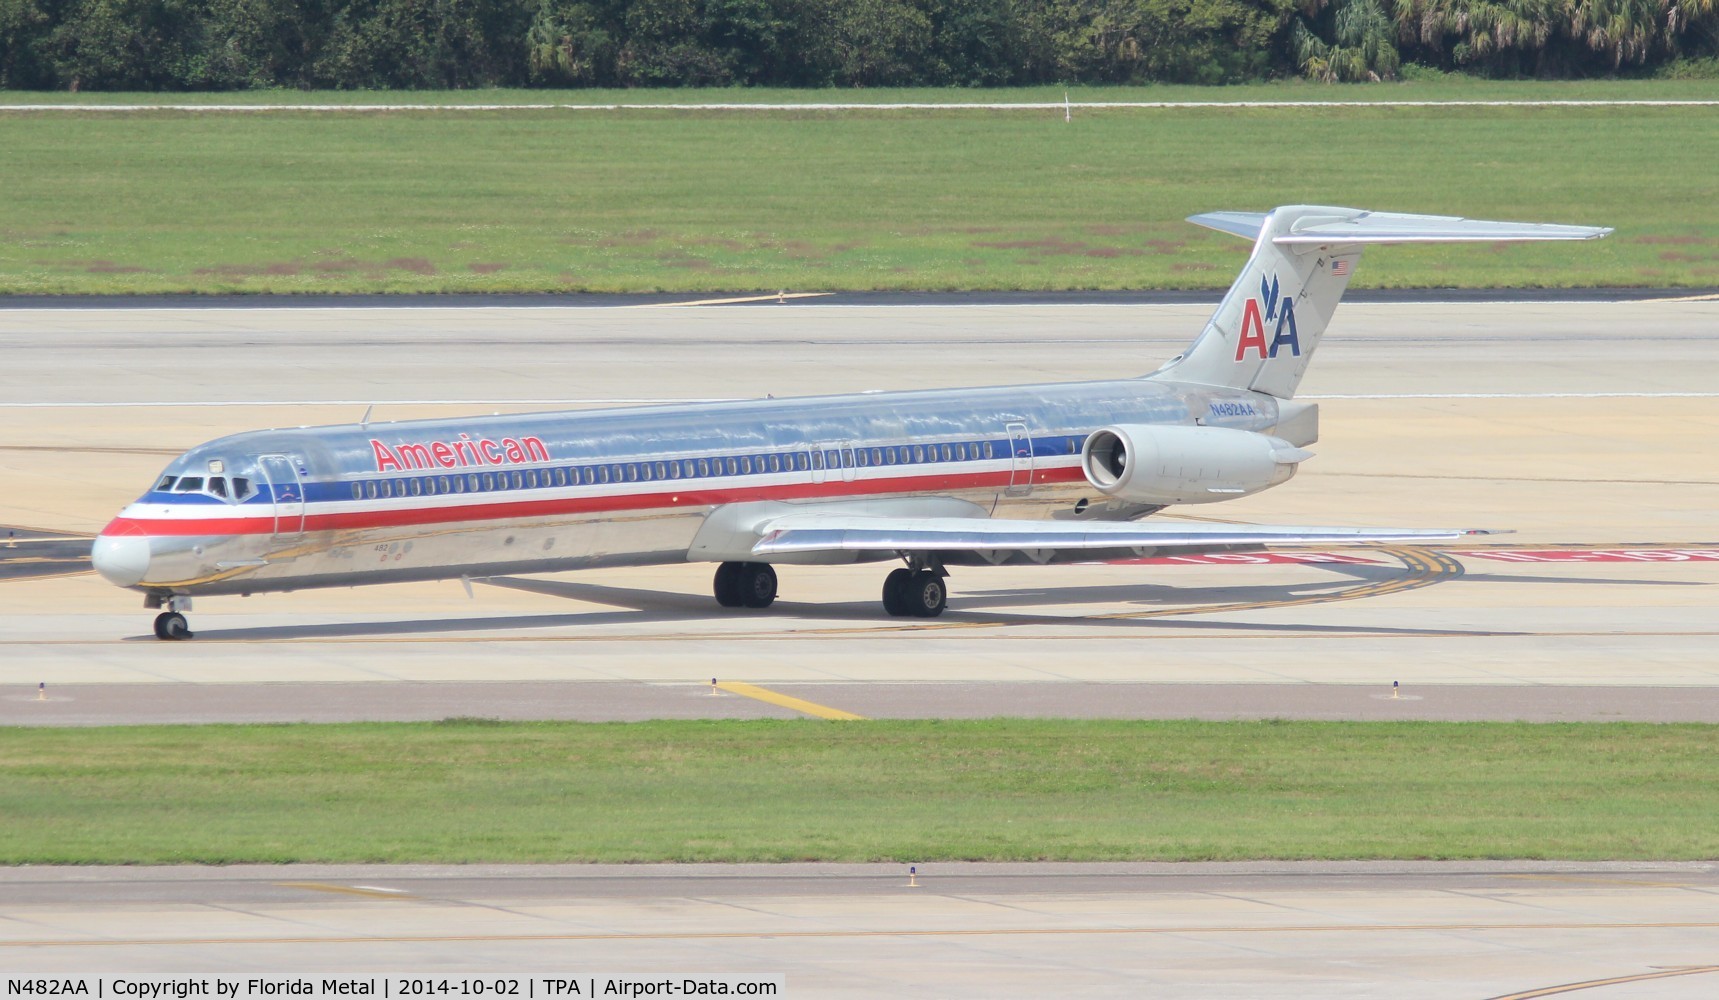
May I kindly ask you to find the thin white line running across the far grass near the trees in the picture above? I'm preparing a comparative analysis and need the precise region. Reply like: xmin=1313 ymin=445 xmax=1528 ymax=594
xmin=0 ymin=100 xmax=1719 ymax=113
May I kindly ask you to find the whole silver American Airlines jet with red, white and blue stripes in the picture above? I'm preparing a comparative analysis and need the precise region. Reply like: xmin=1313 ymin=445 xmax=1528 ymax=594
xmin=91 ymin=206 xmax=1611 ymax=639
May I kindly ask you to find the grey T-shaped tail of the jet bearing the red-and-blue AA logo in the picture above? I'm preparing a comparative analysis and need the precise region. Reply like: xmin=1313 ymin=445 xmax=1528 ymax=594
xmin=1152 ymin=204 xmax=1611 ymax=399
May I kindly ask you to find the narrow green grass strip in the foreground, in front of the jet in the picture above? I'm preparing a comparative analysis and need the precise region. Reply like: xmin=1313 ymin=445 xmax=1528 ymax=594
xmin=0 ymin=720 xmax=1719 ymax=864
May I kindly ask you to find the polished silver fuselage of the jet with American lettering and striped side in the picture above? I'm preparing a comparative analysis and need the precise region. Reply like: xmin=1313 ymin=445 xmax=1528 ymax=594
xmin=103 ymin=378 xmax=1279 ymax=596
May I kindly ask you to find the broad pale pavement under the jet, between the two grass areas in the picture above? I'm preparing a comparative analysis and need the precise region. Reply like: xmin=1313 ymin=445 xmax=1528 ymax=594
xmin=0 ymin=297 xmax=1719 ymax=722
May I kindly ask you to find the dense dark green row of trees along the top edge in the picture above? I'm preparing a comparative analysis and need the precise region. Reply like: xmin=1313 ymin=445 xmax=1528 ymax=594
xmin=0 ymin=0 xmax=1719 ymax=91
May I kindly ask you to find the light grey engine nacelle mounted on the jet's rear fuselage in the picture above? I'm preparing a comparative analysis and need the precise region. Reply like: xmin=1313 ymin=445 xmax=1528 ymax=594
xmin=1080 ymin=424 xmax=1313 ymax=503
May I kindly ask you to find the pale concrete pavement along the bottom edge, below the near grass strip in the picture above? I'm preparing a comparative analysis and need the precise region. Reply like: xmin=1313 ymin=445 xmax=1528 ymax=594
xmin=0 ymin=863 xmax=1719 ymax=1000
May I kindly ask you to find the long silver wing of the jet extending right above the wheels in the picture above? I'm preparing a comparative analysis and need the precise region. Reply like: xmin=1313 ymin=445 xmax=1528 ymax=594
xmin=753 ymin=512 xmax=1492 ymax=562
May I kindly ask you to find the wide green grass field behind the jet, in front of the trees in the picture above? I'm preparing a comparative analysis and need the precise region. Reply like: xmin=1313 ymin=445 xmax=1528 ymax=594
xmin=0 ymin=95 xmax=1719 ymax=294
